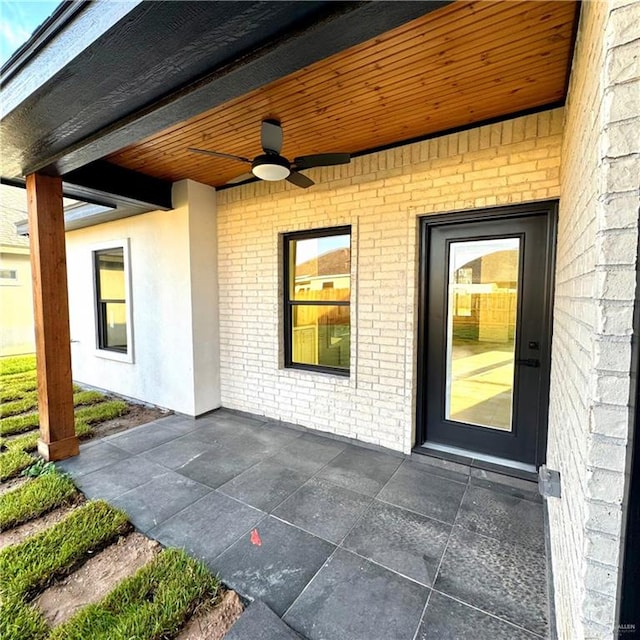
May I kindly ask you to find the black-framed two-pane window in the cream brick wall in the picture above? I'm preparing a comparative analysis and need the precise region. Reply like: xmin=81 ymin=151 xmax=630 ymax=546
xmin=284 ymin=227 xmax=351 ymax=375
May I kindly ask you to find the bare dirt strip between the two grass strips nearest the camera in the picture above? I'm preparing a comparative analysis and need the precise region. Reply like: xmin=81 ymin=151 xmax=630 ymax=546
xmin=34 ymin=533 xmax=161 ymax=626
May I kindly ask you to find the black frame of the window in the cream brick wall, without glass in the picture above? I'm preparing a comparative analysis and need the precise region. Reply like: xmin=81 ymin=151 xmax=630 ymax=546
xmin=282 ymin=225 xmax=353 ymax=378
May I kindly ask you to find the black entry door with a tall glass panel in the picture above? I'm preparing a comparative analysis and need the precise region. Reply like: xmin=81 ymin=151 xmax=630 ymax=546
xmin=421 ymin=208 xmax=551 ymax=464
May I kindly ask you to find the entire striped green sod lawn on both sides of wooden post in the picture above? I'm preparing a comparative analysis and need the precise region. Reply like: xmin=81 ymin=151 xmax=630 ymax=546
xmin=0 ymin=356 xmax=220 ymax=640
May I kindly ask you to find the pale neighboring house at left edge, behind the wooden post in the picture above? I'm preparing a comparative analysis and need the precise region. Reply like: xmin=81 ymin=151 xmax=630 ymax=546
xmin=0 ymin=186 xmax=35 ymax=356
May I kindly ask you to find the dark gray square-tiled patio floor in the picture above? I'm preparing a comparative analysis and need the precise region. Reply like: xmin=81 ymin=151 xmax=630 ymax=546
xmin=60 ymin=410 xmax=548 ymax=640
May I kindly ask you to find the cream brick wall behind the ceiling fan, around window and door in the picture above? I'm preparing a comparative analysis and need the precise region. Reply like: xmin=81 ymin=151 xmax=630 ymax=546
xmin=218 ymin=109 xmax=563 ymax=452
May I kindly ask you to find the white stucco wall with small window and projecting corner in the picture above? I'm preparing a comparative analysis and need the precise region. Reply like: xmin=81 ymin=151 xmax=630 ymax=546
xmin=66 ymin=181 xmax=220 ymax=415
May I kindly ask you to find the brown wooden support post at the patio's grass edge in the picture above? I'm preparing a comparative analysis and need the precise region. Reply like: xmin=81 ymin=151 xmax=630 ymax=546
xmin=27 ymin=173 xmax=79 ymax=460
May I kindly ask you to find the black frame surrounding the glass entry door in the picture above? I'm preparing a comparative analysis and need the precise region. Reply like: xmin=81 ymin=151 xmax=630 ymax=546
xmin=414 ymin=199 xmax=558 ymax=468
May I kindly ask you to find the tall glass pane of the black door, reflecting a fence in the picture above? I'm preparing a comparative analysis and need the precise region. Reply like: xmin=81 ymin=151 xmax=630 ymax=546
xmin=445 ymin=238 xmax=520 ymax=431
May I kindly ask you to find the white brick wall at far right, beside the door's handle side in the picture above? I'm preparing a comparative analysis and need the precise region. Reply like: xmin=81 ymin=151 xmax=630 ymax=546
xmin=548 ymin=0 xmax=640 ymax=640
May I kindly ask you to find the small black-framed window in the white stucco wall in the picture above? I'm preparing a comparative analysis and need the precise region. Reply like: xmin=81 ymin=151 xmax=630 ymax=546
xmin=94 ymin=246 xmax=129 ymax=353
